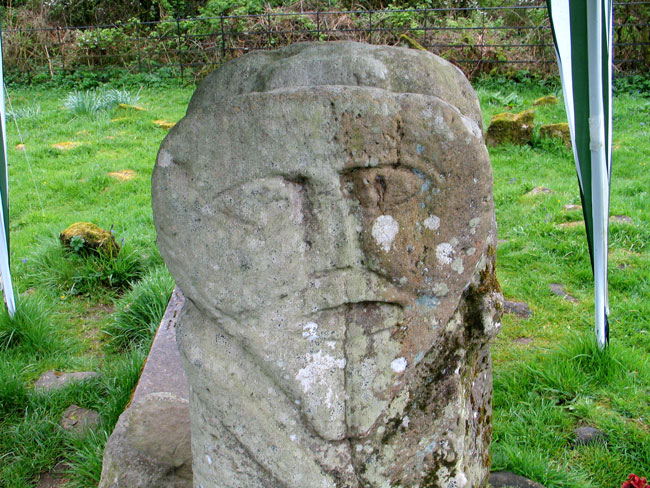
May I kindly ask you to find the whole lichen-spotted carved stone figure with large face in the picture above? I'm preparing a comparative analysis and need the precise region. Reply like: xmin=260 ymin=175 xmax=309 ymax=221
xmin=152 ymin=43 xmax=502 ymax=488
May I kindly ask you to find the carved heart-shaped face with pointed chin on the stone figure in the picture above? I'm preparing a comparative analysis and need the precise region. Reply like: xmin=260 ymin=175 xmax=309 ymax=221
xmin=154 ymin=87 xmax=494 ymax=486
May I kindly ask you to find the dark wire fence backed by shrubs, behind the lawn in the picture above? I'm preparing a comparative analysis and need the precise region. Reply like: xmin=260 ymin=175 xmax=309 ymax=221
xmin=2 ymin=1 xmax=650 ymax=79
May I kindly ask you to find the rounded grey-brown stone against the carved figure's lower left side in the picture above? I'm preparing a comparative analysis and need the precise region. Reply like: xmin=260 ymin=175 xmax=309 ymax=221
xmin=99 ymin=392 xmax=191 ymax=488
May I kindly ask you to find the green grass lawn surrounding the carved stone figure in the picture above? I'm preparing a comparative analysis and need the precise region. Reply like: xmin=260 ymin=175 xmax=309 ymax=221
xmin=0 ymin=81 xmax=650 ymax=488
